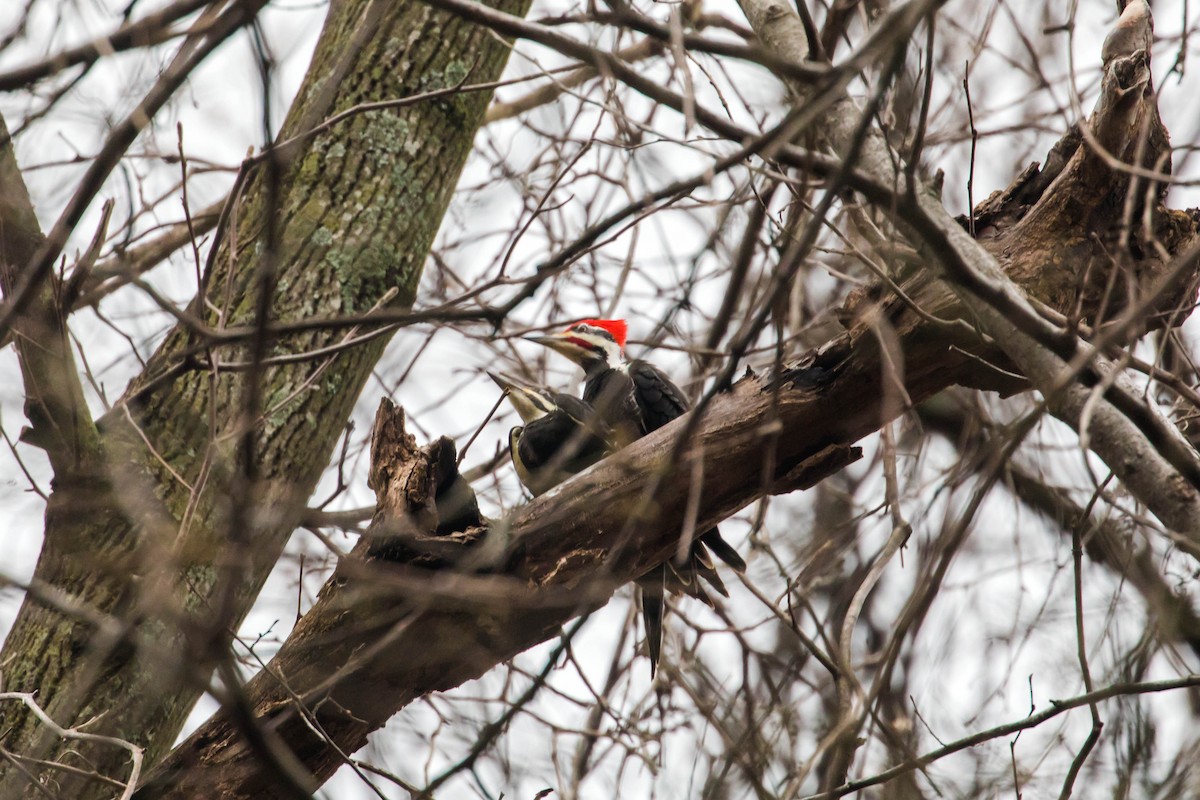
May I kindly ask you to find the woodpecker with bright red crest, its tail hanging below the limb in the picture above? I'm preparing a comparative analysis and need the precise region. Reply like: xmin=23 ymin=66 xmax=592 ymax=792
xmin=529 ymin=319 xmax=746 ymax=676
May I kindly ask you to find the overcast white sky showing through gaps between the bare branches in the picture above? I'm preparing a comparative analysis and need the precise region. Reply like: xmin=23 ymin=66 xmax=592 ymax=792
xmin=0 ymin=0 xmax=1200 ymax=798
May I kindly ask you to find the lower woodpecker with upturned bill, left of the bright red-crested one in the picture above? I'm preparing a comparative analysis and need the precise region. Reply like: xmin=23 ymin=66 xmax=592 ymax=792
xmin=487 ymin=372 xmax=612 ymax=497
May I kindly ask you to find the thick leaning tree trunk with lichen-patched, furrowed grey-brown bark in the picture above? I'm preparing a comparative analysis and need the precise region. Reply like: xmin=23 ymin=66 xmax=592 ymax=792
xmin=0 ymin=0 xmax=526 ymax=798
